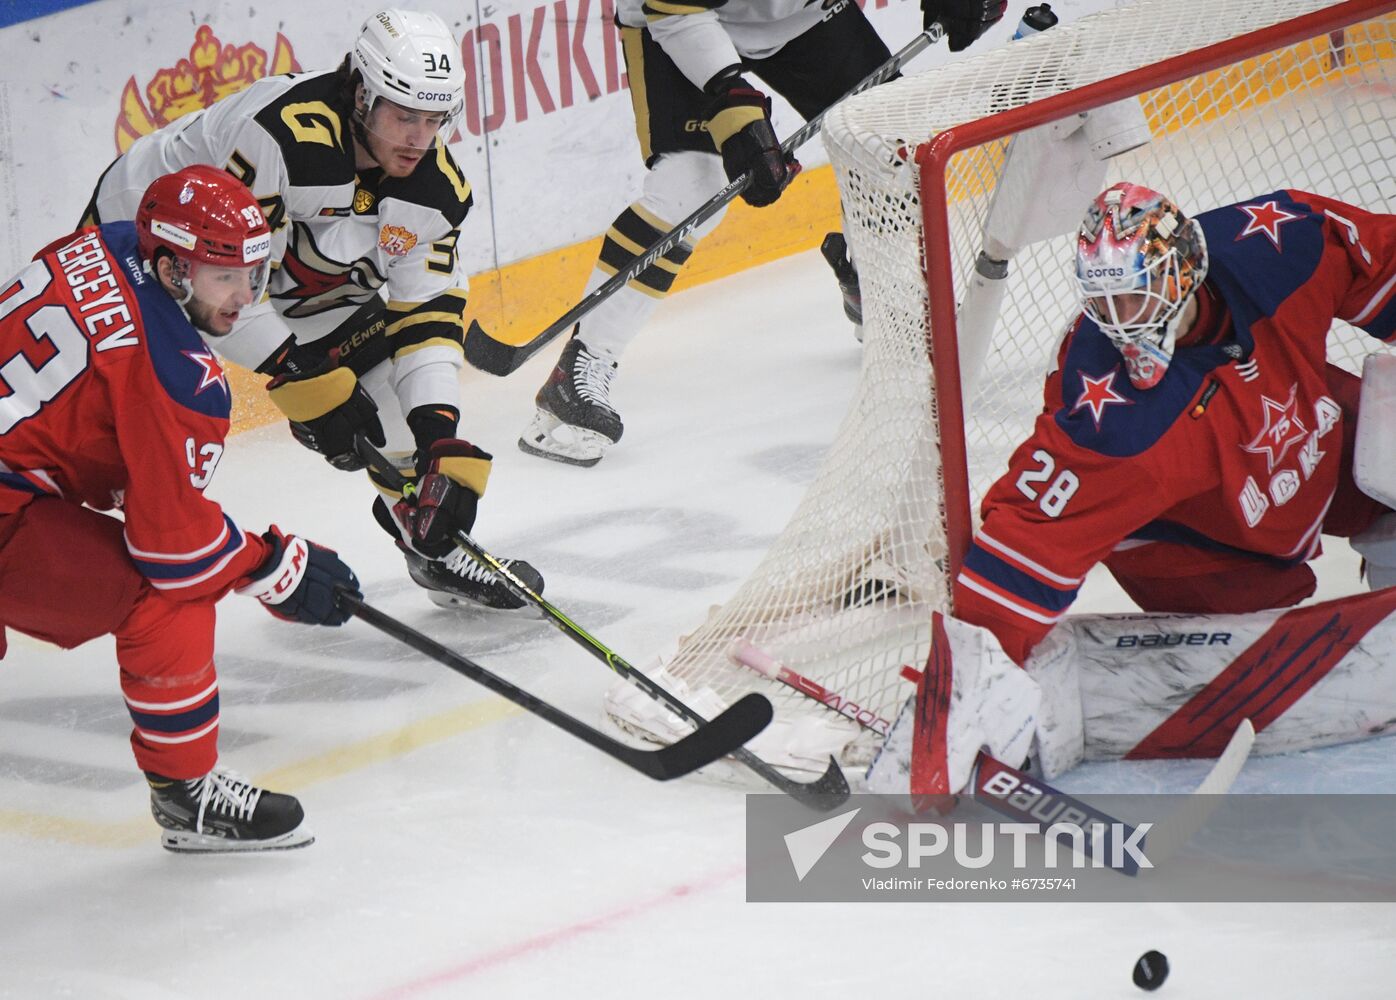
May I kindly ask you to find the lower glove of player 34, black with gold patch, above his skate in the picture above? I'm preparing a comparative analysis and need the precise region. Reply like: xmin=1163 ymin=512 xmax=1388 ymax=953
xmin=392 ymin=437 xmax=493 ymax=559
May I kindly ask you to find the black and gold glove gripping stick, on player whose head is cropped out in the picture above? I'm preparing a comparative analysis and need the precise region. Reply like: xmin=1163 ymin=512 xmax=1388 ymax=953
xmin=704 ymin=66 xmax=800 ymax=208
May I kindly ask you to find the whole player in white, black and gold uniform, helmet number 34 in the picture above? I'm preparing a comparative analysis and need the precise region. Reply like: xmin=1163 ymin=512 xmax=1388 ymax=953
xmin=84 ymin=10 xmax=543 ymax=608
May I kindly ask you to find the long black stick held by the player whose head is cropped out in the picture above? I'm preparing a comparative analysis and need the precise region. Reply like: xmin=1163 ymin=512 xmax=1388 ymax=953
xmin=465 ymin=24 xmax=945 ymax=376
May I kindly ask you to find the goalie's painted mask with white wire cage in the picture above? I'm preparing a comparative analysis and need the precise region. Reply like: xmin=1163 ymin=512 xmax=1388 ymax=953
xmin=1076 ymin=182 xmax=1208 ymax=388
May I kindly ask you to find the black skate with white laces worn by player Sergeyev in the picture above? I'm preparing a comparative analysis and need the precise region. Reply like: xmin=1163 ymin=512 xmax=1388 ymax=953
xmin=145 ymin=770 xmax=315 ymax=853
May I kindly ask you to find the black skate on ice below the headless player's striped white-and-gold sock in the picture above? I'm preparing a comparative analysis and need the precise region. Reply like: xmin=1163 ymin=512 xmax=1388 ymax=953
xmin=519 ymin=334 xmax=624 ymax=466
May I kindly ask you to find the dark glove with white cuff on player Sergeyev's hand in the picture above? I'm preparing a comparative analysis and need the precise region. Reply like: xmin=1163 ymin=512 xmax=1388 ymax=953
xmin=237 ymin=525 xmax=363 ymax=626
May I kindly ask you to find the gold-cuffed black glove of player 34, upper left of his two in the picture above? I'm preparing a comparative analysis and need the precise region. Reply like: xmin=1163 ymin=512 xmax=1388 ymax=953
xmin=267 ymin=367 xmax=387 ymax=471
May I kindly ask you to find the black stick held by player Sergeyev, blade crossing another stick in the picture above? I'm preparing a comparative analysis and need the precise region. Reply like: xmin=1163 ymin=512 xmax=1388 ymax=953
xmin=338 ymin=591 xmax=772 ymax=781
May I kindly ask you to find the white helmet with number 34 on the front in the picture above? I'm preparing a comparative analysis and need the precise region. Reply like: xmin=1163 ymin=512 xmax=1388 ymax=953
xmin=349 ymin=10 xmax=465 ymax=133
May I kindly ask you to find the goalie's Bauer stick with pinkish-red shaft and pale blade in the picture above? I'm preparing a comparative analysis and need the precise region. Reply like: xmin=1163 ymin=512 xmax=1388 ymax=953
xmin=727 ymin=638 xmax=1255 ymax=874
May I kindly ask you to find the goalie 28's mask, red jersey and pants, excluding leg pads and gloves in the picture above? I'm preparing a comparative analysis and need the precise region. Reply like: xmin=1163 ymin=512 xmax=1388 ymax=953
xmin=955 ymin=183 xmax=1396 ymax=662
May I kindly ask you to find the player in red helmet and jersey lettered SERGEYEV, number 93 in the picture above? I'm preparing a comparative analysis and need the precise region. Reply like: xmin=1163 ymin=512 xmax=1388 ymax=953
xmin=0 ymin=166 xmax=359 ymax=851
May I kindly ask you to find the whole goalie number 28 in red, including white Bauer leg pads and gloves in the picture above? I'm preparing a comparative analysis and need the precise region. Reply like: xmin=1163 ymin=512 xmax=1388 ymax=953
xmin=868 ymin=183 xmax=1396 ymax=793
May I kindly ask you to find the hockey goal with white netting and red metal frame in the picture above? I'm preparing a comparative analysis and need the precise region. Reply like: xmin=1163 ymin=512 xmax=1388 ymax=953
xmin=607 ymin=0 xmax=1396 ymax=770
